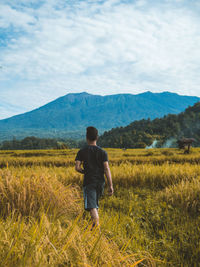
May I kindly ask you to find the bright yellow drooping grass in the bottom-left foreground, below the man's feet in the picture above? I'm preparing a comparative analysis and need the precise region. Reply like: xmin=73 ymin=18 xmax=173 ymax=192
xmin=0 ymin=213 xmax=136 ymax=266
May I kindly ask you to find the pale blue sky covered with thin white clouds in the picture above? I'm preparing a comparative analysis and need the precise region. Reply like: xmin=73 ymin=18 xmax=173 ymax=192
xmin=0 ymin=0 xmax=200 ymax=119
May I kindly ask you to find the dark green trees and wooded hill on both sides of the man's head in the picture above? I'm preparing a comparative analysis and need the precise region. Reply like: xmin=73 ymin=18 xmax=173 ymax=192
xmin=0 ymin=102 xmax=200 ymax=153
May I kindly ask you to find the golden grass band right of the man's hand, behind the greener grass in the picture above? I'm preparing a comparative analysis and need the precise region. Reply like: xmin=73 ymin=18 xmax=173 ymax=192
xmin=112 ymin=162 xmax=200 ymax=190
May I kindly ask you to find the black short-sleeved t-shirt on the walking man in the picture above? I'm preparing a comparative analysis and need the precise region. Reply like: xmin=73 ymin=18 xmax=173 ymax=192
xmin=75 ymin=145 xmax=108 ymax=186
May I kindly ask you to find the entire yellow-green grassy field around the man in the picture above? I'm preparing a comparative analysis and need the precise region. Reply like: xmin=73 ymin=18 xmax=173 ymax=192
xmin=0 ymin=148 xmax=200 ymax=267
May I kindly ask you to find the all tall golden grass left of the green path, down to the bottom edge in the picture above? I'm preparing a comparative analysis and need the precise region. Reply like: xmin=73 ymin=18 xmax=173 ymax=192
xmin=0 ymin=168 xmax=147 ymax=266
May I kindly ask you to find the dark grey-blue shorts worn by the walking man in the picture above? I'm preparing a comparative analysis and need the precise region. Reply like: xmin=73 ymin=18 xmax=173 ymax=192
xmin=83 ymin=183 xmax=104 ymax=211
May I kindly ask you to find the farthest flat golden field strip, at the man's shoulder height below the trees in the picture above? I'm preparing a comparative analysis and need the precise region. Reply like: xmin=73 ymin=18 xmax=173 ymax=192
xmin=0 ymin=148 xmax=200 ymax=168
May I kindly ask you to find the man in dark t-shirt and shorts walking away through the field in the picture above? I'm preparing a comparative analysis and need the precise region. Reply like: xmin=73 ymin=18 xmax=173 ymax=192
xmin=75 ymin=126 xmax=114 ymax=227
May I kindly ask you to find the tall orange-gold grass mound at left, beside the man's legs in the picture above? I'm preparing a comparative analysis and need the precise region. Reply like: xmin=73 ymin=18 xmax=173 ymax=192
xmin=0 ymin=169 xmax=80 ymax=220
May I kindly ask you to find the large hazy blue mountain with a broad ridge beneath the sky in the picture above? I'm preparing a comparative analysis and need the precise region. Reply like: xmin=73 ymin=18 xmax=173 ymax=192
xmin=0 ymin=92 xmax=199 ymax=140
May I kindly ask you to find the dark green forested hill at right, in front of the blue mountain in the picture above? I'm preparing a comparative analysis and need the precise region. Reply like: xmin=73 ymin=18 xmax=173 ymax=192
xmin=98 ymin=102 xmax=200 ymax=148
